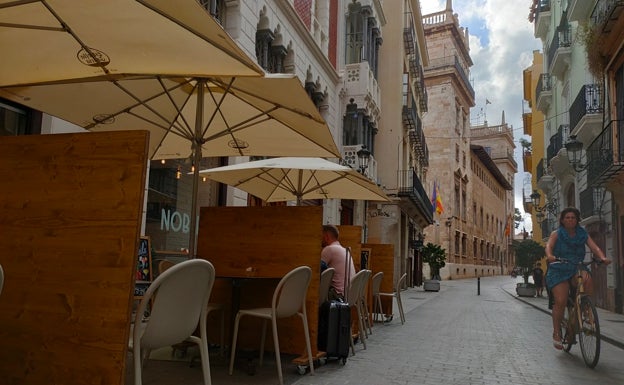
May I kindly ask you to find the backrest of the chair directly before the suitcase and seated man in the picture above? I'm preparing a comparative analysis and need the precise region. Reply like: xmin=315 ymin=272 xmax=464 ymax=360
xmin=271 ymin=266 xmax=312 ymax=318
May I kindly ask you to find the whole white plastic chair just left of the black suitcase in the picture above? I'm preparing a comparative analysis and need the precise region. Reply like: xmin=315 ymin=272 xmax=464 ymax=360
xmin=229 ymin=266 xmax=314 ymax=384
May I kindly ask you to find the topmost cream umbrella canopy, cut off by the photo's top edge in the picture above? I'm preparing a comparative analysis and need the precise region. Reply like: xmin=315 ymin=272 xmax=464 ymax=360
xmin=0 ymin=0 xmax=264 ymax=86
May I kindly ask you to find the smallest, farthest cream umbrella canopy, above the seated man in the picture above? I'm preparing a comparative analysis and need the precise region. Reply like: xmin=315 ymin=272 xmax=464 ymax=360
xmin=200 ymin=157 xmax=389 ymax=204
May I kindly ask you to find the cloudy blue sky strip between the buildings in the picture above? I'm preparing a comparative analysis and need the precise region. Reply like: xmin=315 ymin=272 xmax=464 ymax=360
xmin=420 ymin=0 xmax=541 ymax=231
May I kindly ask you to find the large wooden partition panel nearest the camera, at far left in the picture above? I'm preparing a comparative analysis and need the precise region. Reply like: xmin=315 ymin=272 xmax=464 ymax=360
xmin=0 ymin=131 xmax=149 ymax=385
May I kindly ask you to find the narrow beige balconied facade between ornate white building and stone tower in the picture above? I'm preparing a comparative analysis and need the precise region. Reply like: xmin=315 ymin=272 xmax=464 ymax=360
xmin=367 ymin=0 xmax=433 ymax=286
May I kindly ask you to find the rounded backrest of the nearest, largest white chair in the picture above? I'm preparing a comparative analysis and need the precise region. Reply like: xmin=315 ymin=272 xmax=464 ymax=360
xmin=134 ymin=259 xmax=215 ymax=348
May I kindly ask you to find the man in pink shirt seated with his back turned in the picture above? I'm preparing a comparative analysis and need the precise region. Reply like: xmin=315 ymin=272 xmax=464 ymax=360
xmin=321 ymin=225 xmax=355 ymax=300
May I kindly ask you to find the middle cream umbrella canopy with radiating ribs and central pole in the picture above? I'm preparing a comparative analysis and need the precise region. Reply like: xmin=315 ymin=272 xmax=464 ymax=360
xmin=0 ymin=74 xmax=340 ymax=159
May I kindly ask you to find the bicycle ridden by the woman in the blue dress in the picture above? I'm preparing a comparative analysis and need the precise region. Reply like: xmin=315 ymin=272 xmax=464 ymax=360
xmin=557 ymin=258 xmax=602 ymax=368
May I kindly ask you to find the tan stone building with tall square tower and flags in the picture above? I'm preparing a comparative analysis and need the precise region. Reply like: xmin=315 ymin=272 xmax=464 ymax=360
xmin=423 ymin=0 xmax=517 ymax=279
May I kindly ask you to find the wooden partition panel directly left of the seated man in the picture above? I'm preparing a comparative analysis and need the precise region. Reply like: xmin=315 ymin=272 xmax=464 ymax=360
xmin=197 ymin=206 xmax=323 ymax=354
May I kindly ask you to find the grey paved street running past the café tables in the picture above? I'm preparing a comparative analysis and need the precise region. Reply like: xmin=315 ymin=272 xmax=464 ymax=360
xmin=128 ymin=277 xmax=624 ymax=385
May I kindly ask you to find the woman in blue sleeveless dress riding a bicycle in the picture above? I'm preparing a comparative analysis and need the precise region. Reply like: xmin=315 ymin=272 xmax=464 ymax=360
xmin=546 ymin=207 xmax=611 ymax=350
